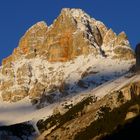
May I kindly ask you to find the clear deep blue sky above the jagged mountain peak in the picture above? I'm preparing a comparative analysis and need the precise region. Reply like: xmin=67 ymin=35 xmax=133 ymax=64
xmin=0 ymin=0 xmax=140 ymax=61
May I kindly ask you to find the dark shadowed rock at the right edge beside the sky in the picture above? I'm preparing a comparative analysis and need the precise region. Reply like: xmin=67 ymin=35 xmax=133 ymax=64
xmin=135 ymin=44 xmax=140 ymax=71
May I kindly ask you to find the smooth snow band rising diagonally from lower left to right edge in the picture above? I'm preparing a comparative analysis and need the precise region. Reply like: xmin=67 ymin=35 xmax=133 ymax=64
xmin=0 ymin=73 xmax=140 ymax=139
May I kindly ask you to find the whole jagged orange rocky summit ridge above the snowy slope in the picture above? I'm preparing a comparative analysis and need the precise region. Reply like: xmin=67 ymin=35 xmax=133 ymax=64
xmin=2 ymin=9 xmax=134 ymax=65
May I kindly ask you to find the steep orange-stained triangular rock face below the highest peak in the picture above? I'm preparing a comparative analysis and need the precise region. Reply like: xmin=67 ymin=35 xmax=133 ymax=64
xmin=43 ymin=9 xmax=90 ymax=62
